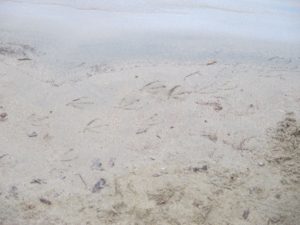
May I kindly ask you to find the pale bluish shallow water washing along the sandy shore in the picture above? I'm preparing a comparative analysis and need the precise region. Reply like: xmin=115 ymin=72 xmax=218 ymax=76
xmin=0 ymin=0 xmax=300 ymax=64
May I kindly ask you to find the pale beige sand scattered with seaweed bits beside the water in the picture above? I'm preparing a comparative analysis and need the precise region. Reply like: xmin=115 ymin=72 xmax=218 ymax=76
xmin=0 ymin=0 xmax=300 ymax=225
